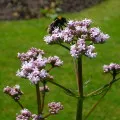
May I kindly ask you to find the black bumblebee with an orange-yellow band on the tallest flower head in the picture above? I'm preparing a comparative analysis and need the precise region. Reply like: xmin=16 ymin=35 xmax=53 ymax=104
xmin=48 ymin=16 xmax=67 ymax=34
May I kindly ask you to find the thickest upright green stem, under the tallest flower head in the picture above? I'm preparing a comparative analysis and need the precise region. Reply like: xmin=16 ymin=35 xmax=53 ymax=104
xmin=76 ymin=56 xmax=83 ymax=120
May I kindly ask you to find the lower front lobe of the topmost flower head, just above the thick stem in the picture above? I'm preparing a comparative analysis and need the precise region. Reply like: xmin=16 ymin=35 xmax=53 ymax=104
xmin=70 ymin=38 xmax=97 ymax=58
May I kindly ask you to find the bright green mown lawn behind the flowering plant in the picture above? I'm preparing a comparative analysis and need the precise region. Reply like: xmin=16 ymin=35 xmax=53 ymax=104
xmin=0 ymin=0 xmax=120 ymax=120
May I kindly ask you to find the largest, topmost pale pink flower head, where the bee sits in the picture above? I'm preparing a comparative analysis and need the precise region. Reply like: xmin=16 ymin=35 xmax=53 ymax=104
xmin=44 ymin=19 xmax=109 ymax=58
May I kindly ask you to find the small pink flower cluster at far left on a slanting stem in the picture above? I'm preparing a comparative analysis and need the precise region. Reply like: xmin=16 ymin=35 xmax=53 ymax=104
xmin=3 ymin=85 xmax=23 ymax=100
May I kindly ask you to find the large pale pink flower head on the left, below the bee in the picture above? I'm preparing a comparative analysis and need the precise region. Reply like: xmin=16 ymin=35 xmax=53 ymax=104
xmin=16 ymin=48 xmax=63 ymax=84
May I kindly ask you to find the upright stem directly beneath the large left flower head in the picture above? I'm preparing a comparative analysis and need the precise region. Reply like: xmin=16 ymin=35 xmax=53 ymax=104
xmin=36 ymin=83 xmax=41 ymax=115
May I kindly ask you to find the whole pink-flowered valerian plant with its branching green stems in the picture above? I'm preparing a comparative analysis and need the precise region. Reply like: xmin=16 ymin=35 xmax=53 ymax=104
xmin=3 ymin=19 xmax=120 ymax=120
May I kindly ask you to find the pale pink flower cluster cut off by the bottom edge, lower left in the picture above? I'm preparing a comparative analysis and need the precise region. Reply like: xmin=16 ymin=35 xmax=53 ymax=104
xmin=16 ymin=109 xmax=32 ymax=120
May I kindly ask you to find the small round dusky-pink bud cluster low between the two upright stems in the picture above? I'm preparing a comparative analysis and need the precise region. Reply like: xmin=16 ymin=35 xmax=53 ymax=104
xmin=48 ymin=102 xmax=63 ymax=114
